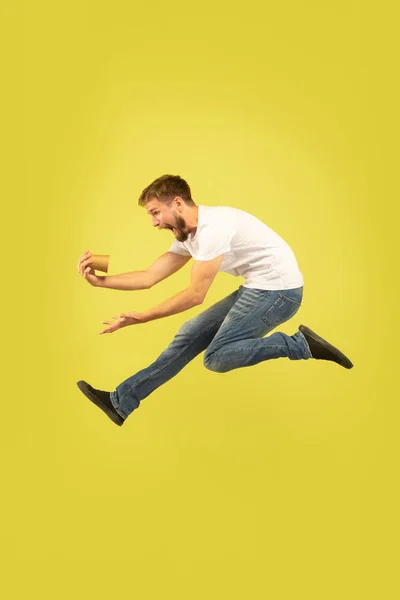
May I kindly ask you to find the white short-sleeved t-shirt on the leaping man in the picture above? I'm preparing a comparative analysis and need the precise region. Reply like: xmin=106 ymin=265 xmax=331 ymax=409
xmin=169 ymin=205 xmax=304 ymax=290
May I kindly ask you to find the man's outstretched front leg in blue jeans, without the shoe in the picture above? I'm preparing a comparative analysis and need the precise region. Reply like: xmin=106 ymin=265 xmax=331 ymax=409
xmin=111 ymin=288 xmax=240 ymax=419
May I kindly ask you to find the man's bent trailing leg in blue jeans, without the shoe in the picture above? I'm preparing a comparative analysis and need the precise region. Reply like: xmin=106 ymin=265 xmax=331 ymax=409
xmin=204 ymin=287 xmax=312 ymax=373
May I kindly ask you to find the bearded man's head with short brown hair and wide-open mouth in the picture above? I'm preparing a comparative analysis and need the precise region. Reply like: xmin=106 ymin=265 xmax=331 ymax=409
xmin=139 ymin=175 xmax=197 ymax=242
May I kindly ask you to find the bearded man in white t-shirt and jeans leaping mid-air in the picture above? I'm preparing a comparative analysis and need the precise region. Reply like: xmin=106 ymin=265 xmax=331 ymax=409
xmin=77 ymin=175 xmax=353 ymax=425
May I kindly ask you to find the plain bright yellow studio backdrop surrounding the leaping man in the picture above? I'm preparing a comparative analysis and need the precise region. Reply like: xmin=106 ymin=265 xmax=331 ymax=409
xmin=6 ymin=0 xmax=399 ymax=600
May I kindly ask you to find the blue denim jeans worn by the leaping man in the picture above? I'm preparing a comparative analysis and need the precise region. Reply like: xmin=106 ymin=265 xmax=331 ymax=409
xmin=111 ymin=285 xmax=312 ymax=419
